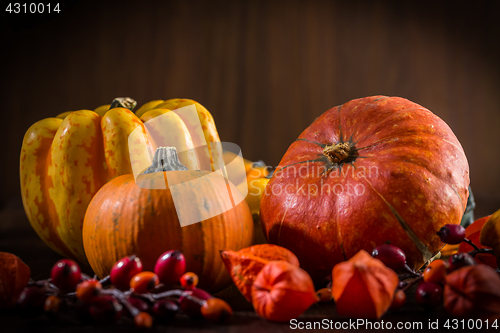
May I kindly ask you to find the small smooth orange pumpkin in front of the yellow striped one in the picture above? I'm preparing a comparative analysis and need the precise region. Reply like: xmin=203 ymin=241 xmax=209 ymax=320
xmin=83 ymin=171 xmax=253 ymax=291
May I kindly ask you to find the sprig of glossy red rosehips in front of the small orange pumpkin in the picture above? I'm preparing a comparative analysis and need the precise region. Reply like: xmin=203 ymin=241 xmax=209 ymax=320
xmin=18 ymin=250 xmax=232 ymax=328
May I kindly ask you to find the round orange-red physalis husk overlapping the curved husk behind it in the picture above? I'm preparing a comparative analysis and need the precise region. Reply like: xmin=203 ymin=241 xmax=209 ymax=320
xmin=252 ymin=261 xmax=319 ymax=322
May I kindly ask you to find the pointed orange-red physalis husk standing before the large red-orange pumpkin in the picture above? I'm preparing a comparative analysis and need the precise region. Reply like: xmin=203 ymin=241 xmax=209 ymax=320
xmin=332 ymin=250 xmax=399 ymax=319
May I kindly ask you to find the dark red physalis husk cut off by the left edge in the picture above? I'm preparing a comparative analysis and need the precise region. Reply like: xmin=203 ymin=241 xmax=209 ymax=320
xmin=0 ymin=252 xmax=31 ymax=309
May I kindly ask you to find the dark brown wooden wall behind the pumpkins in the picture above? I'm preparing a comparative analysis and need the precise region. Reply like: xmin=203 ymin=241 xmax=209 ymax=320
xmin=0 ymin=0 xmax=500 ymax=214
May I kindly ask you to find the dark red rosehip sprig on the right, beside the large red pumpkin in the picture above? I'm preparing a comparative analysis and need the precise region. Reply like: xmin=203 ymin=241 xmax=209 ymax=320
xmin=372 ymin=224 xmax=491 ymax=309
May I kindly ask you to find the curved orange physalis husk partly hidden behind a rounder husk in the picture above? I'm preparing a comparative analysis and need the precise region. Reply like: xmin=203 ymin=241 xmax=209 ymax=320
xmin=221 ymin=244 xmax=299 ymax=302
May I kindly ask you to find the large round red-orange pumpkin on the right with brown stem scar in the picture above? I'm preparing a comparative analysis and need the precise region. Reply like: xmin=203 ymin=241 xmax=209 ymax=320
xmin=260 ymin=96 xmax=469 ymax=282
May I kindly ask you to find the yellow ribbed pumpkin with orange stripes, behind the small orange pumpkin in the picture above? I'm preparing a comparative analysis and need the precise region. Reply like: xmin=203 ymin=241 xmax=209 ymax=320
xmin=20 ymin=98 xmax=222 ymax=263
